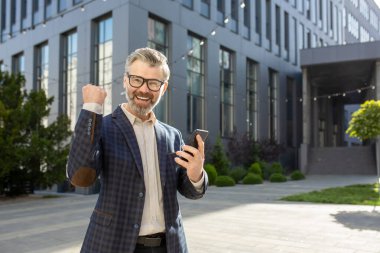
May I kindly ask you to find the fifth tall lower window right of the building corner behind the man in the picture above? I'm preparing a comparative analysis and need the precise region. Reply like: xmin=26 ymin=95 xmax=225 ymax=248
xmin=268 ymin=69 xmax=278 ymax=142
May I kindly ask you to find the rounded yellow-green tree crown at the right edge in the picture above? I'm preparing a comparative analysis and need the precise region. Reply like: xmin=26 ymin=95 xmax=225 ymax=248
xmin=346 ymin=100 xmax=380 ymax=141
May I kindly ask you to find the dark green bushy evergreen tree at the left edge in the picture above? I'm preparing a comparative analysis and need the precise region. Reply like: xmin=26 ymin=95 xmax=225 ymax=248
xmin=0 ymin=72 xmax=71 ymax=195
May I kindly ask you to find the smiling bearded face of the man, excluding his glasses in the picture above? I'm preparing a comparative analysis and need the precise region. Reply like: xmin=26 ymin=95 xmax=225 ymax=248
xmin=124 ymin=60 xmax=168 ymax=120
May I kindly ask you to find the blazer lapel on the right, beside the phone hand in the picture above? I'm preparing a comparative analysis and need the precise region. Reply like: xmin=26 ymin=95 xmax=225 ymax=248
xmin=154 ymin=121 xmax=167 ymax=190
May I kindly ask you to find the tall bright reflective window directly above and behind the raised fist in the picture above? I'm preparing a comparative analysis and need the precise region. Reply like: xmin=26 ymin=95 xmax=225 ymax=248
xmin=93 ymin=16 xmax=112 ymax=115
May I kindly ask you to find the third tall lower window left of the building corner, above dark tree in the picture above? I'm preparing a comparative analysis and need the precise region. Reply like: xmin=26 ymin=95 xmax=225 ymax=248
xmin=34 ymin=42 xmax=49 ymax=94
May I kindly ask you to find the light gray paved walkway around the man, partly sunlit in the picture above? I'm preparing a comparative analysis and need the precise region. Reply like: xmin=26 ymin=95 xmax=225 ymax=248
xmin=0 ymin=176 xmax=380 ymax=253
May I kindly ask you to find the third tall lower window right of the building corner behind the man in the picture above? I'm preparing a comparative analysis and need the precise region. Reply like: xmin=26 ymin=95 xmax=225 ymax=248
xmin=219 ymin=48 xmax=234 ymax=137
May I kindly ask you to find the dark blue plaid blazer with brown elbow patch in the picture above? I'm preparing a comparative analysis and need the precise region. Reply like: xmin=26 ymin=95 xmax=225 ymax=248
xmin=67 ymin=107 xmax=208 ymax=253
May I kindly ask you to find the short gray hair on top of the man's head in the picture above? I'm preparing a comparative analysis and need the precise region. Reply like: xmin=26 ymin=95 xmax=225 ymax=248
xmin=125 ymin=47 xmax=170 ymax=81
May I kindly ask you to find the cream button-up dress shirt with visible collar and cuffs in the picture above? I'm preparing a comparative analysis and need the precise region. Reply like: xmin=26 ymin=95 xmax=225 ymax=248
xmin=83 ymin=103 xmax=204 ymax=236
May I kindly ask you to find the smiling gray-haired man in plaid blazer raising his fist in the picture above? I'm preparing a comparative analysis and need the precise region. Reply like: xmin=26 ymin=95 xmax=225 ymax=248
xmin=67 ymin=48 xmax=208 ymax=253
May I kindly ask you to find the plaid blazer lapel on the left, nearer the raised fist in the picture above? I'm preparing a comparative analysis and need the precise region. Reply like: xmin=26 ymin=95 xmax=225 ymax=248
xmin=112 ymin=106 xmax=144 ymax=178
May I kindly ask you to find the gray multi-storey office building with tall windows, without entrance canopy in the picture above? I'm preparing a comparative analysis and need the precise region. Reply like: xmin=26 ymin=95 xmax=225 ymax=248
xmin=0 ymin=0 xmax=380 ymax=175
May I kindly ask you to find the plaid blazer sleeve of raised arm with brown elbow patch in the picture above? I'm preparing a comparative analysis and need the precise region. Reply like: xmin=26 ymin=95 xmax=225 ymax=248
xmin=66 ymin=109 xmax=103 ymax=187
